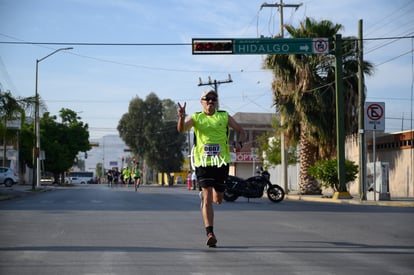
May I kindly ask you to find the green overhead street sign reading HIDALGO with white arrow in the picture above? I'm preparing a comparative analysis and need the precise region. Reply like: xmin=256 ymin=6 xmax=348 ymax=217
xmin=233 ymin=38 xmax=329 ymax=54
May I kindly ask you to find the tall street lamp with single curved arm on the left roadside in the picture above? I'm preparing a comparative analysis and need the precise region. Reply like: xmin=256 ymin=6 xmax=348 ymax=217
xmin=32 ymin=47 xmax=73 ymax=189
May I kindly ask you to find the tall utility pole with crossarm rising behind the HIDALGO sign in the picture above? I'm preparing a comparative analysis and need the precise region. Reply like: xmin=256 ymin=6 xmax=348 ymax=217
xmin=260 ymin=0 xmax=302 ymax=192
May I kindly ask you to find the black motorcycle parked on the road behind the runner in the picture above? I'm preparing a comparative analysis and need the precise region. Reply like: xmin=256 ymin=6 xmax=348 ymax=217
xmin=223 ymin=168 xmax=285 ymax=202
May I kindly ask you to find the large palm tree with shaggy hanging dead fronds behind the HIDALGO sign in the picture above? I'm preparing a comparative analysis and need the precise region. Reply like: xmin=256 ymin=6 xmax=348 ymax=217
xmin=264 ymin=18 xmax=372 ymax=194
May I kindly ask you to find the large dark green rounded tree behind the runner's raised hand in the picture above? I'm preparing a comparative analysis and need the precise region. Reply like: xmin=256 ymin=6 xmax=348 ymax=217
xmin=117 ymin=93 xmax=185 ymax=182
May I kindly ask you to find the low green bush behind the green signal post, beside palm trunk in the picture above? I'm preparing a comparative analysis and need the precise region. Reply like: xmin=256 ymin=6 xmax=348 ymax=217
xmin=309 ymin=159 xmax=358 ymax=192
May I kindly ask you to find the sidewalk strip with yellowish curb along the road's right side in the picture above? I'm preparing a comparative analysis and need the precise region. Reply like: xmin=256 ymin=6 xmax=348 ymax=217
xmin=285 ymin=194 xmax=414 ymax=207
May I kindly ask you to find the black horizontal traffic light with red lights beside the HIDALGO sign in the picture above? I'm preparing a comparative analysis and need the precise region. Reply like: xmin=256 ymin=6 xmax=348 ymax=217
xmin=192 ymin=39 xmax=233 ymax=54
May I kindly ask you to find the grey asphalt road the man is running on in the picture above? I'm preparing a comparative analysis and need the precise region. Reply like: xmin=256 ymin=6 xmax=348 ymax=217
xmin=0 ymin=185 xmax=414 ymax=275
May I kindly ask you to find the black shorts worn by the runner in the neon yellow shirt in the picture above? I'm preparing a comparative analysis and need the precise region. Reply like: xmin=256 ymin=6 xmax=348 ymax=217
xmin=196 ymin=165 xmax=229 ymax=192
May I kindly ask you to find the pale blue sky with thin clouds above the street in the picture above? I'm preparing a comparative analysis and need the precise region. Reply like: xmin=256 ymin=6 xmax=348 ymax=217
xmin=0 ymin=0 xmax=414 ymax=144
